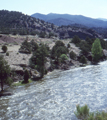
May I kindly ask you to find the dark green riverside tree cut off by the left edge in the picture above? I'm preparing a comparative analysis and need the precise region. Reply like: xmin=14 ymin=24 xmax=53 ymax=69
xmin=0 ymin=56 xmax=11 ymax=91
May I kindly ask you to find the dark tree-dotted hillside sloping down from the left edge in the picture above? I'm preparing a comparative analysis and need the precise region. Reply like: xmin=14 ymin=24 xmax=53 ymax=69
xmin=0 ymin=10 xmax=57 ymax=35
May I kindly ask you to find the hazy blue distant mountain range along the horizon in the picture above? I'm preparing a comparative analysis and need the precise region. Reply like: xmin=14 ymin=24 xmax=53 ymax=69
xmin=31 ymin=13 xmax=107 ymax=28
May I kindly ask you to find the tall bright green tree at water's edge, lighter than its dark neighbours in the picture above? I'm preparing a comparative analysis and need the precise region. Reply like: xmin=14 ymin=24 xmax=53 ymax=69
xmin=91 ymin=38 xmax=102 ymax=62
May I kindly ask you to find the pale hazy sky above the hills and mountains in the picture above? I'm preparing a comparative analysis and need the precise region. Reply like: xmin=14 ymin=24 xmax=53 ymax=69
xmin=0 ymin=0 xmax=107 ymax=18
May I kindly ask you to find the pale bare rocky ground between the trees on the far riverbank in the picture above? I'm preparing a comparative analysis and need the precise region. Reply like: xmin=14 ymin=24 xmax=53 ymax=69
xmin=0 ymin=36 xmax=107 ymax=93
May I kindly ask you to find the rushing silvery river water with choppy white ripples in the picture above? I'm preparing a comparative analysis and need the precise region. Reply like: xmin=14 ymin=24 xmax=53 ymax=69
xmin=0 ymin=61 xmax=107 ymax=120
